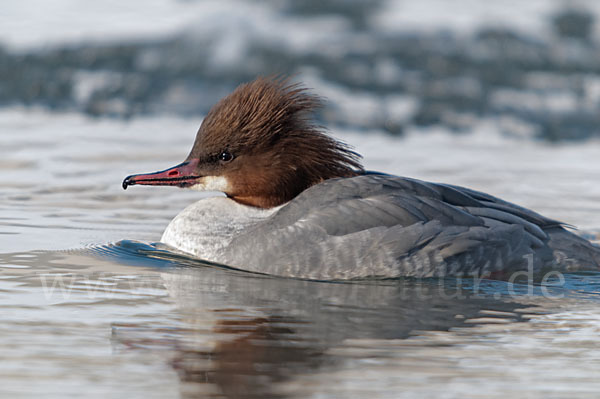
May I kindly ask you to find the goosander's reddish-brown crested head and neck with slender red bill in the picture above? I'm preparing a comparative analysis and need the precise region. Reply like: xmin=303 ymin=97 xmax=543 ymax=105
xmin=123 ymin=78 xmax=363 ymax=208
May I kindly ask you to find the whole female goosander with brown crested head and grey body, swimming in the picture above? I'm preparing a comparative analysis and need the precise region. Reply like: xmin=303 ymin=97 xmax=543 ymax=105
xmin=123 ymin=78 xmax=600 ymax=280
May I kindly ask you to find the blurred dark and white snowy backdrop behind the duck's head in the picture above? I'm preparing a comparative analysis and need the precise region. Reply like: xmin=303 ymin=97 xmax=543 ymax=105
xmin=0 ymin=0 xmax=600 ymax=141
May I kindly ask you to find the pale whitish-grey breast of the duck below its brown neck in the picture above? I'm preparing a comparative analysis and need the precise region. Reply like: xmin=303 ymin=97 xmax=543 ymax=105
xmin=160 ymin=197 xmax=280 ymax=263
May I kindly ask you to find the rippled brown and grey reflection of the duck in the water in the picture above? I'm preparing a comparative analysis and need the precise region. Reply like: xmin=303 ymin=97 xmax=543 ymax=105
xmin=110 ymin=250 xmax=525 ymax=398
